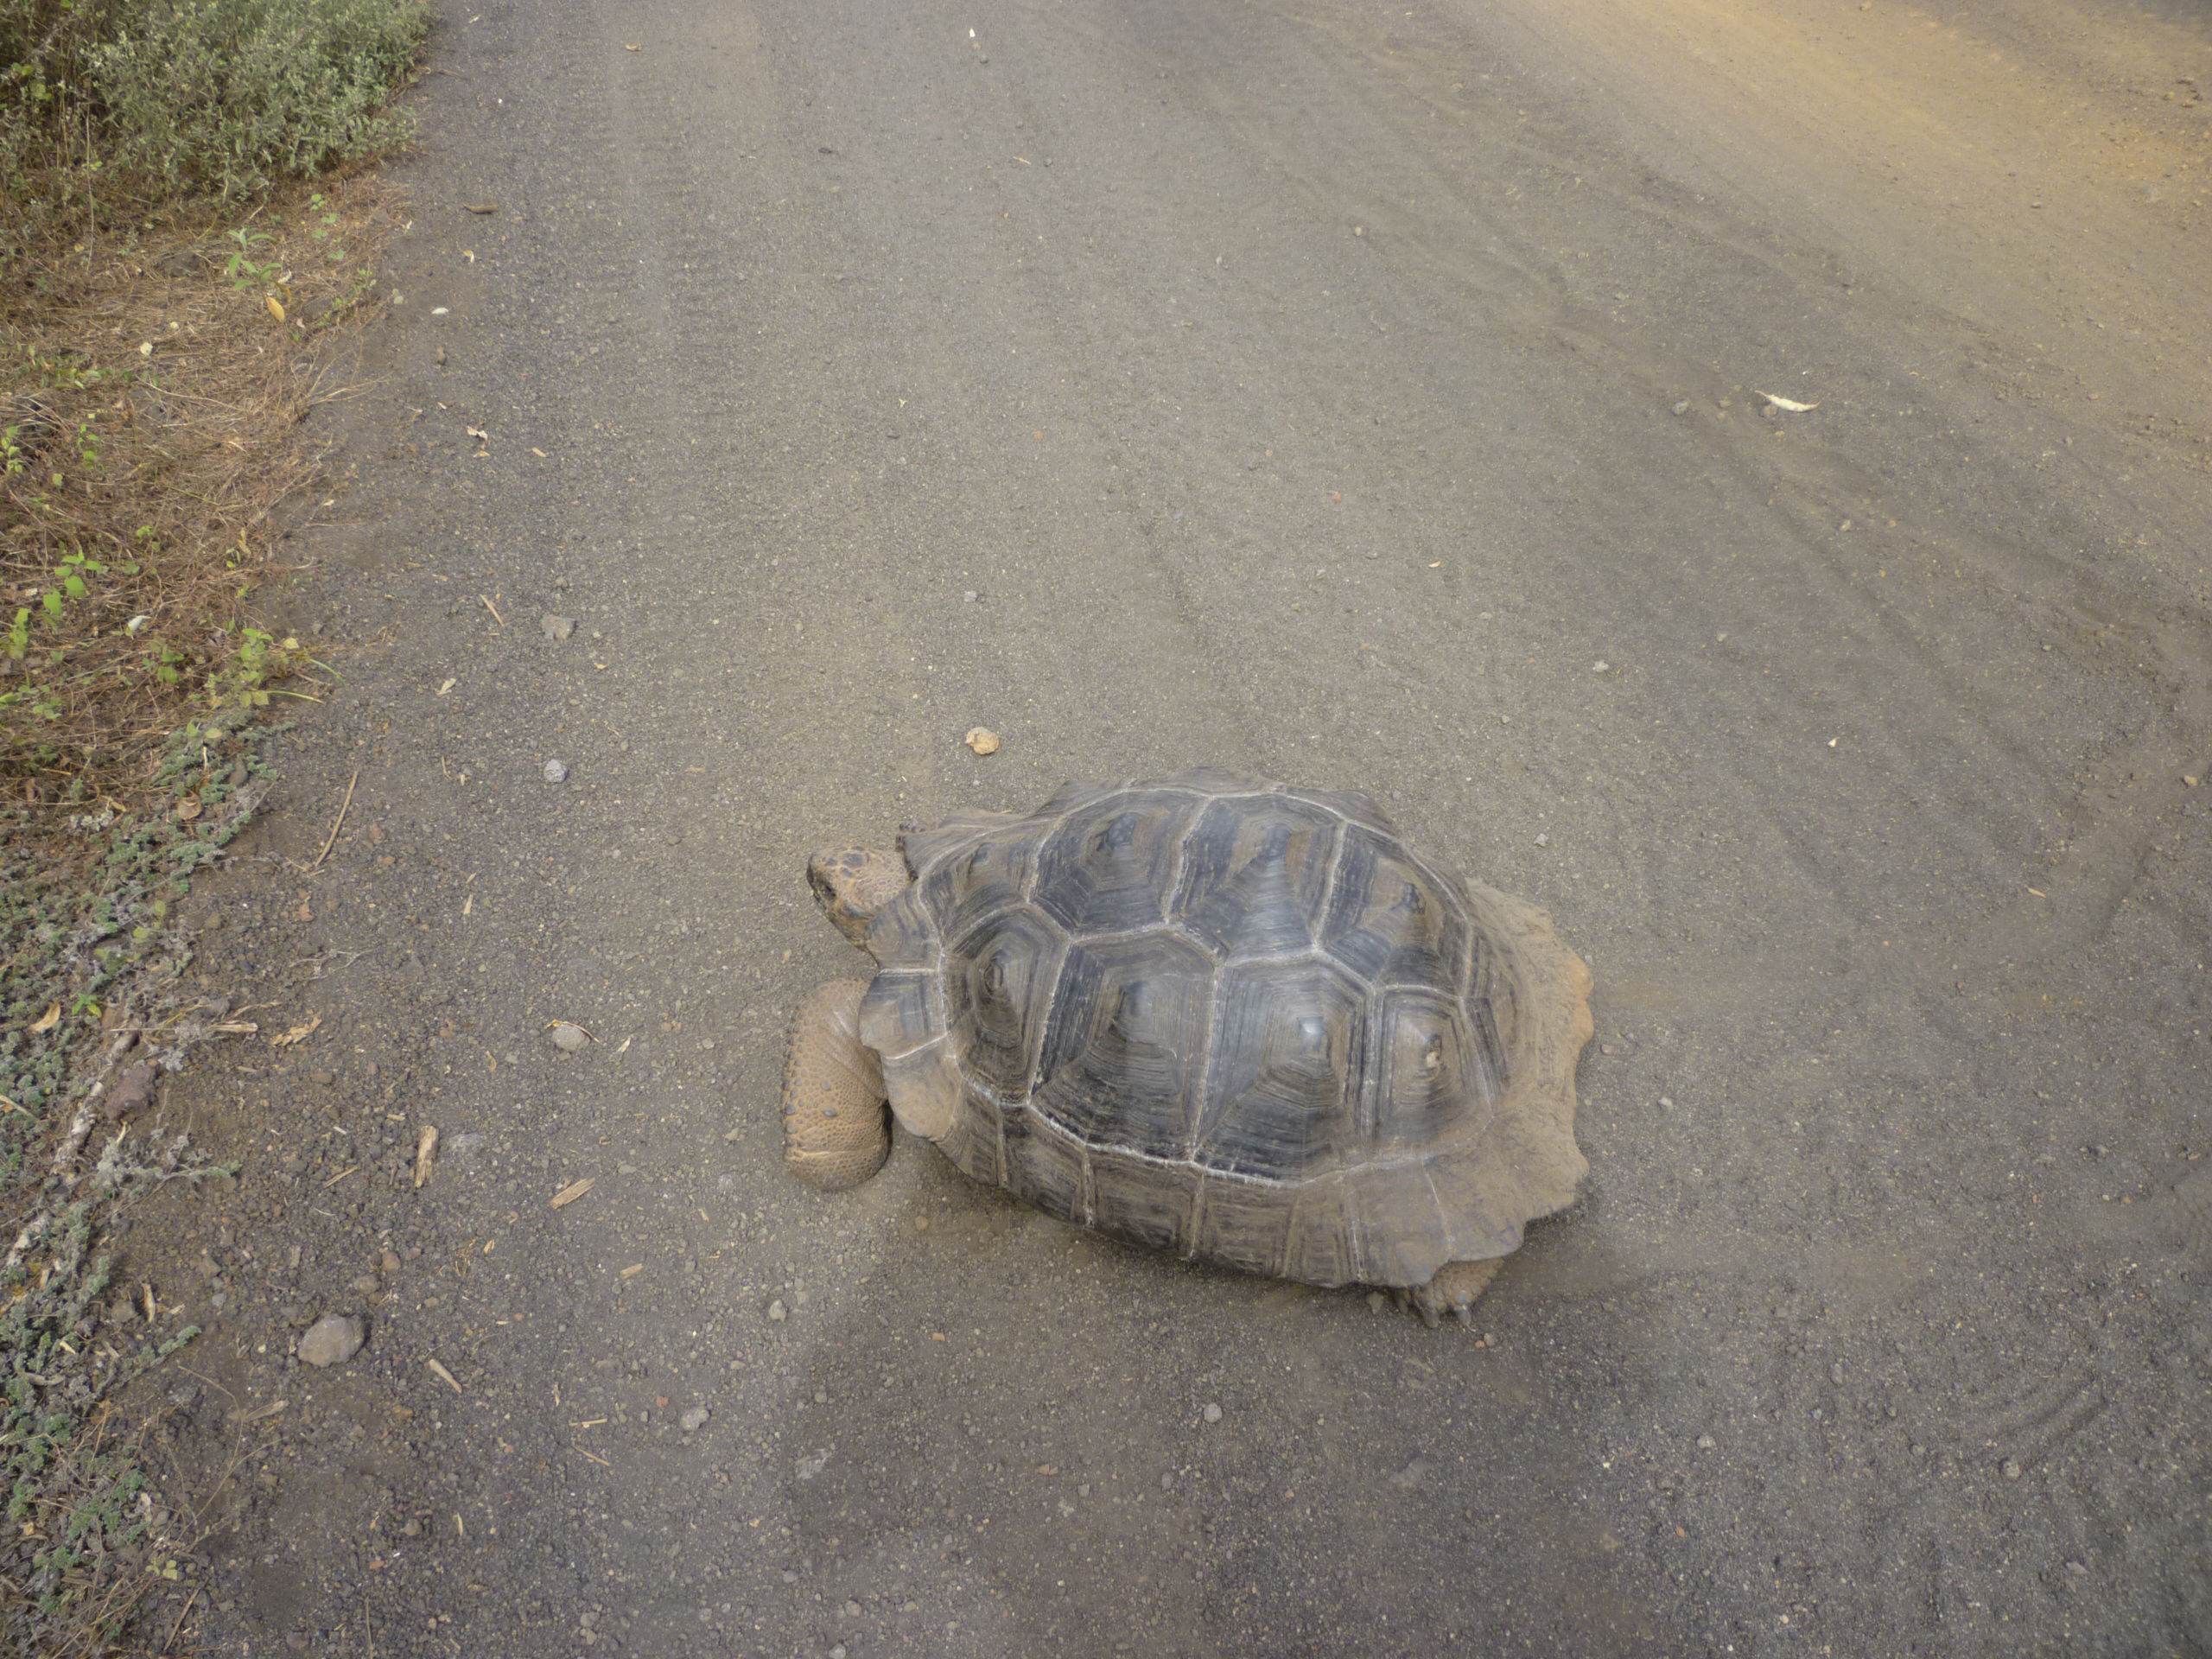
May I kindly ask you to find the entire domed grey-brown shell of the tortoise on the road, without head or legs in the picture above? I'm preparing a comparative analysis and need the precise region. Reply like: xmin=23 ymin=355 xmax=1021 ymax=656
xmin=861 ymin=772 xmax=1591 ymax=1285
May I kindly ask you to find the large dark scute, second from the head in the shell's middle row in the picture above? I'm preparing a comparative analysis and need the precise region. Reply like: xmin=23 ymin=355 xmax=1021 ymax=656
xmin=1031 ymin=931 xmax=1214 ymax=1157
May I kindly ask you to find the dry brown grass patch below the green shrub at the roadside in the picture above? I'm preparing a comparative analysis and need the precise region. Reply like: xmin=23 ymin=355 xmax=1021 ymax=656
xmin=0 ymin=173 xmax=400 ymax=817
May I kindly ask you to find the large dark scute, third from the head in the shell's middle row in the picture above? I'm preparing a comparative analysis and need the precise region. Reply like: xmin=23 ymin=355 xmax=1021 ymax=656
xmin=1192 ymin=956 xmax=1370 ymax=1181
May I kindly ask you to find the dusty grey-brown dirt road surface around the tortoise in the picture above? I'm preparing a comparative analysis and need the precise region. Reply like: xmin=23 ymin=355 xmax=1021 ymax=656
xmin=107 ymin=0 xmax=2212 ymax=1656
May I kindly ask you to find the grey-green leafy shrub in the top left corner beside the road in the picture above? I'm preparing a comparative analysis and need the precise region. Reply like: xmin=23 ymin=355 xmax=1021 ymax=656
xmin=0 ymin=0 xmax=429 ymax=197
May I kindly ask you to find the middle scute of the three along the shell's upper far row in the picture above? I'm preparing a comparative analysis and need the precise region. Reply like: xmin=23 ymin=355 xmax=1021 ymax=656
xmin=1174 ymin=794 xmax=1343 ymax=956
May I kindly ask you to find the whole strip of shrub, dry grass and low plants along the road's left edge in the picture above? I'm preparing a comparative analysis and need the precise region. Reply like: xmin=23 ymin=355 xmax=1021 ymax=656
xmin=0 ymin=0 xmax=429 ymax=1655
